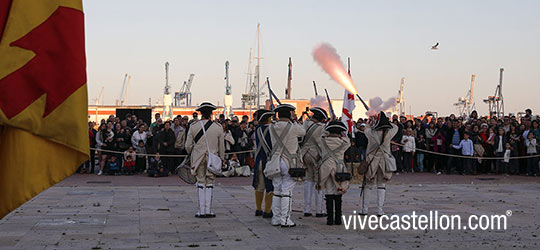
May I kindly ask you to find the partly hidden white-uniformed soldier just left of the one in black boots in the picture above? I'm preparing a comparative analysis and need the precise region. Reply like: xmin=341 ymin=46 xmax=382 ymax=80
xmin=301 ymin=107 xmax=328 ymax=217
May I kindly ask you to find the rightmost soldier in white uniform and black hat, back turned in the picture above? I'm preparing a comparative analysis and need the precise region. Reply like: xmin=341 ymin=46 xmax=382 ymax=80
xmin=360 ymin=112 xmax=398 ymax=216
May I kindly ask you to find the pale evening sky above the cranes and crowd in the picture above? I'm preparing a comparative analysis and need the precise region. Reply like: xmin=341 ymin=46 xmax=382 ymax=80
xmin=83 ymin=0 xmax=540 ymax=115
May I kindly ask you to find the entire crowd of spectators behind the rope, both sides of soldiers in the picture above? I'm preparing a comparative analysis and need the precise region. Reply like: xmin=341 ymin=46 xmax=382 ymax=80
xmin=78 ymin=109 xmax=540 ymax=177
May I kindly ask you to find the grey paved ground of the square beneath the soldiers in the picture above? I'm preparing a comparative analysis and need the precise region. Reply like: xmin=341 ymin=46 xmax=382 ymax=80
xmin=0 ymin=174 xmax=540 ymax=249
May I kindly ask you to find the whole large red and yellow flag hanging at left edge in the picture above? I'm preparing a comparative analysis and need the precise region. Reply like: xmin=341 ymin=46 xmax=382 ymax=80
xmin=0 ymin=0 xmax=89 ymax=218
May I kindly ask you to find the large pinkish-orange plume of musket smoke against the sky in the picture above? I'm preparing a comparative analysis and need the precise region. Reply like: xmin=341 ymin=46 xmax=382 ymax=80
xmin=313 ymin=43 xmax=358 ymax=95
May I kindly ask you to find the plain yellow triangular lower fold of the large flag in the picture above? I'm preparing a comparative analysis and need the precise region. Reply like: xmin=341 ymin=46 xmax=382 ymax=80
xmin=0 ymin=126 xmax=88 ymax=218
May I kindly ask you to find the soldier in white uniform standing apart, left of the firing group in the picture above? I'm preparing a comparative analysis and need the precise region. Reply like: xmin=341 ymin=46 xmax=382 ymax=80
xmin=185 ymin=102 xmax=225 ymax=218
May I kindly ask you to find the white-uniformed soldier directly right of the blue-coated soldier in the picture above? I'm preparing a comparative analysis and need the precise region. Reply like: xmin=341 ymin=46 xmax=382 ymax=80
xmin=267 ymin=104 xmax=306 ymax=227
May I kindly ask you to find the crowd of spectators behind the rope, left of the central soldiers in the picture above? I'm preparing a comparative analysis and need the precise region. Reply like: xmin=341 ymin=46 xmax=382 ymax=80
xmin=77 ymin=112 xmax=256 ymax=177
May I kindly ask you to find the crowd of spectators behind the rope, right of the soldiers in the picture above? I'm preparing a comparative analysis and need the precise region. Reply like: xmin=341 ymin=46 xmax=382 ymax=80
xmin=345 ymin=109 xmax=540 ymax=176
